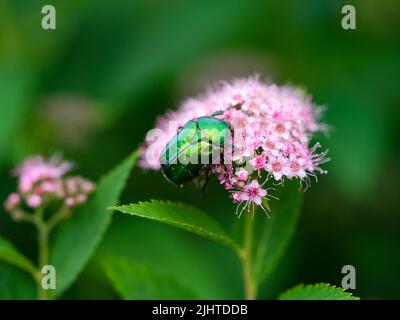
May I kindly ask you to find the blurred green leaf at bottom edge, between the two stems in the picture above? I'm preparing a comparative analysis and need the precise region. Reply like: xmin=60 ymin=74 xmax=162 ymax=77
xmin=102 ymin=256 xmax=196 ymax=300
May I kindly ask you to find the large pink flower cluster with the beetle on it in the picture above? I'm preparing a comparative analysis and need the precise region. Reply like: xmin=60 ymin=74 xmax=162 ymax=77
xmin=140 ymin=77 xmax=327 ymax=214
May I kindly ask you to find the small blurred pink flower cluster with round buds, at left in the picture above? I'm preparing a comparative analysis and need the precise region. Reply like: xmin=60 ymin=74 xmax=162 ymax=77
xmin=4 ymin=156 xmax=95 ymax=212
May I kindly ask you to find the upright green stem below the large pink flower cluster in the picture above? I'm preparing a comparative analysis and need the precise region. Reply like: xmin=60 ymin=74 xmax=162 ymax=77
xmin=239 ymin=214 xmax=257 ymax=300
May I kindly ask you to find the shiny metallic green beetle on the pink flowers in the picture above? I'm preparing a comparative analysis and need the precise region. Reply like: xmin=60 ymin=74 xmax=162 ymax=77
xmin=160 ymin=113 xmax=232 ymax=188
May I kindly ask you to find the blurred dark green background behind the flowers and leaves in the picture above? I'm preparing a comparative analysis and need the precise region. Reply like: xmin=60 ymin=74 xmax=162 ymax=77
xmin=0 ymin=0 xmax=400 ymax=299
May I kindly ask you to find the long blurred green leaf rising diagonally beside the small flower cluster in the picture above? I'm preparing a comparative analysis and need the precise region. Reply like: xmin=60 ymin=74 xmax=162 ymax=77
xmin=50 ymin=151 xmax=138 ymax=296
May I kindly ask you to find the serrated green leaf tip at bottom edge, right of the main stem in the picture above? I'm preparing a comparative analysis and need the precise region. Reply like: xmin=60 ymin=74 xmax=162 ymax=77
xmin=278 ymin=283 xmax=360 ymax=300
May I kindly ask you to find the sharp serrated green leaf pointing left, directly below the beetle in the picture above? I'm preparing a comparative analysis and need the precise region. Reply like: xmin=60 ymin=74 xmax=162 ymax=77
xmin=110 ymin=200 xmax=237 ymax=249
